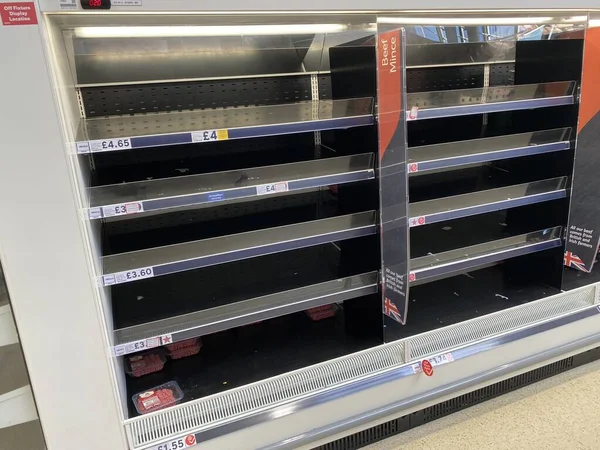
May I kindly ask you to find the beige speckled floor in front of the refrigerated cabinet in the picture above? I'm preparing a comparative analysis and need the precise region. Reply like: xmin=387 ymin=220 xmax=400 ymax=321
xmin=366 ymin=361 xmax=600 ymax=450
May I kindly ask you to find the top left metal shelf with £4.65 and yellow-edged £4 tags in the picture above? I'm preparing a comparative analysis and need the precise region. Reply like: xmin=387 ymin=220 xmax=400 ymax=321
xmin=76 ymin=98 xmax=375 ymax=154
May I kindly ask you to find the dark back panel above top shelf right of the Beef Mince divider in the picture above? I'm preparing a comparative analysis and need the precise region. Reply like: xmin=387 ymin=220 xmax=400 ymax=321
xmin=406 ymin=63 xmax=515 ymax=93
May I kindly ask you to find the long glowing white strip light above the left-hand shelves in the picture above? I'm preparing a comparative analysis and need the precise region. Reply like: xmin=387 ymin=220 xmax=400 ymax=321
xmin=75 ymin=24 xmax=348 ymax=38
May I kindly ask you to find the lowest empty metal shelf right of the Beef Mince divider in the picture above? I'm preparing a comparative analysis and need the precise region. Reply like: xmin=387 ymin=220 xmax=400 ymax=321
xmin=409 ymin=227 xmax=562 ymax=284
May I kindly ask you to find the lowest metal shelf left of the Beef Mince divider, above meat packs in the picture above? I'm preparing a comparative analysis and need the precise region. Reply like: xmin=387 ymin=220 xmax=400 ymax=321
xmin=114 ymin=272 xmax=379 ymax=355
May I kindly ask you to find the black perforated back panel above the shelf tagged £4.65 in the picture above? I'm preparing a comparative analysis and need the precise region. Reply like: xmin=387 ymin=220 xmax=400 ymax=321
xmin=81 ymin=75 xmax=331 ymax=118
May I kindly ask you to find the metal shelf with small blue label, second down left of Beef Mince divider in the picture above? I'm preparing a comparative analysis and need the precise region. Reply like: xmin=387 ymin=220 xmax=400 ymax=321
xmin=89 ymin=153 xmax=374 ymax=219
